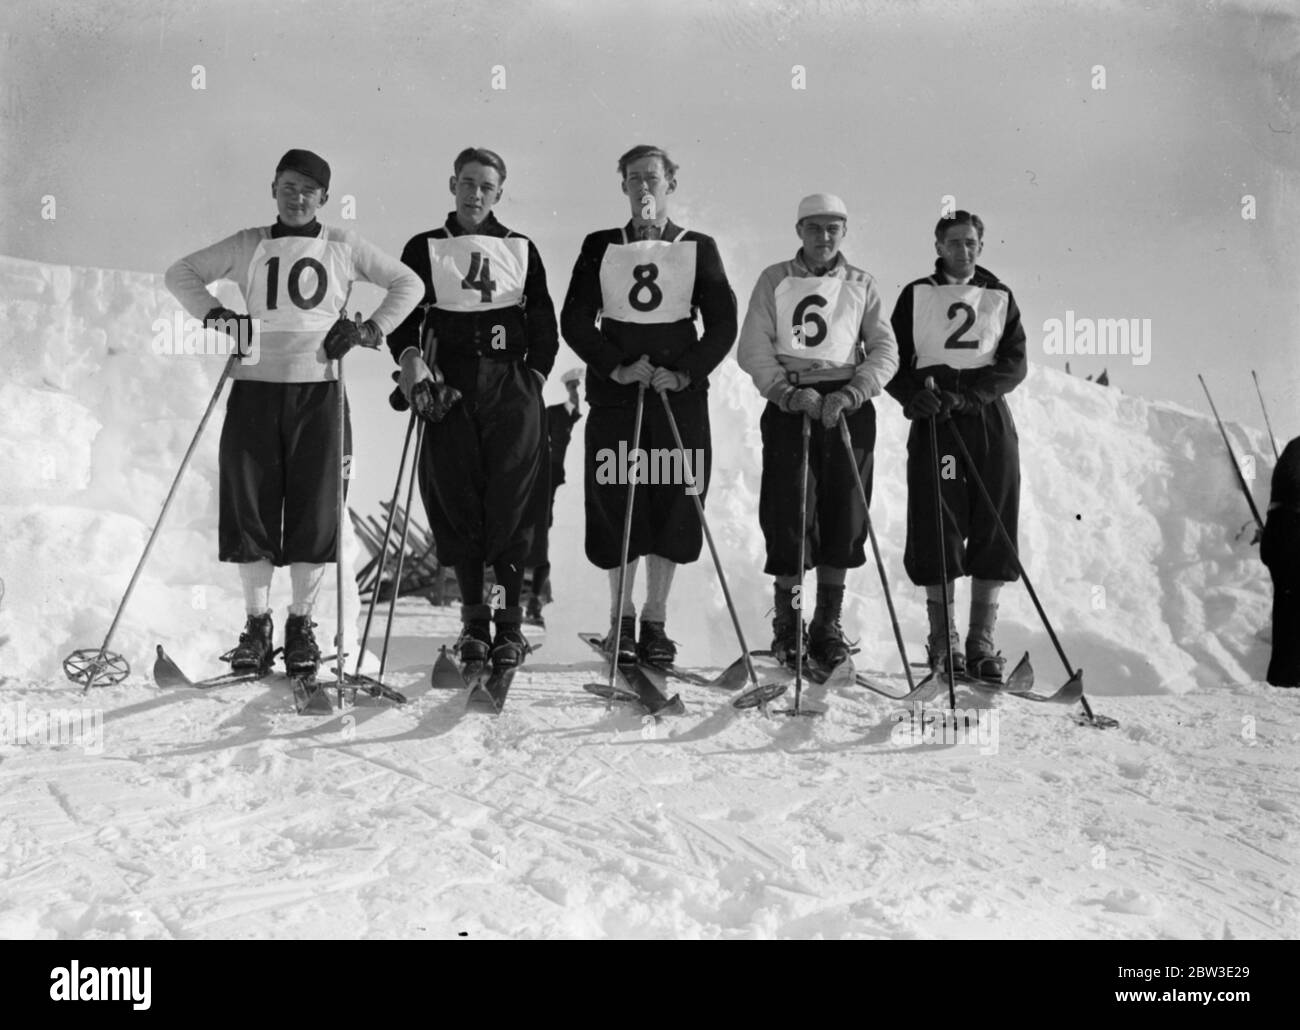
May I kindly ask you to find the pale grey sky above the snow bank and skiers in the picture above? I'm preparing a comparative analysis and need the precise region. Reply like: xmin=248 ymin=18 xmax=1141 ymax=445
xmin=0 ymin=0 xmax=1300 ymax=515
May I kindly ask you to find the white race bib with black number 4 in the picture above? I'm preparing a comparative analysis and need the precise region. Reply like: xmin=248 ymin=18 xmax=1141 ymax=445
xmin=429 ymin=235 xmax=528 ymax=311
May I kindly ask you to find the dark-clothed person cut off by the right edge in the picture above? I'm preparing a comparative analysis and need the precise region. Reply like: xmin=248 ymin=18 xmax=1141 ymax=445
xmin=1260 ymin=437 xmax=1300 ymax=687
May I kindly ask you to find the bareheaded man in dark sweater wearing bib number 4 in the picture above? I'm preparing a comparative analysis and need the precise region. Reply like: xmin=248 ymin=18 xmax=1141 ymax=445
xmin=389 ymin=147 xmax=559 ymax=668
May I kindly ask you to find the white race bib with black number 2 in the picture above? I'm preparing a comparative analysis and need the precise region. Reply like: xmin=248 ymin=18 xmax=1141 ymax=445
xmin=911 ymin=284 xmax=1008 ymax=368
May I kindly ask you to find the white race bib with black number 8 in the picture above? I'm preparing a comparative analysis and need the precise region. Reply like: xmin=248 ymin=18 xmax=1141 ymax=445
xmin=601 ymin=239 xmax=696 ymax=324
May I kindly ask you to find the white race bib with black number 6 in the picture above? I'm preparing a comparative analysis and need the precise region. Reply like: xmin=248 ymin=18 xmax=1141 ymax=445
xmin=775 ymin=276 xmax=867 ymax=368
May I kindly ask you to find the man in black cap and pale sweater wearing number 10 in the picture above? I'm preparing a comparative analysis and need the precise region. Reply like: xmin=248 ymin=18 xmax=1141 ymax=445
xmin=166 ymin=150 xmax=420 ymax=674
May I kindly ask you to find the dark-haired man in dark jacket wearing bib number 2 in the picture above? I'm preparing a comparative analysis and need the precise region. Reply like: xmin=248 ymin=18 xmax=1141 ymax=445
xmin=887 ymin=211 xmax=1027 ymax=681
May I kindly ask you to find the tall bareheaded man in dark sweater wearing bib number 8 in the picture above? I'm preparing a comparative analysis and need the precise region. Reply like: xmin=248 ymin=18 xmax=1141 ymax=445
xmin=560 ymin=146 xmax=736 ymax=662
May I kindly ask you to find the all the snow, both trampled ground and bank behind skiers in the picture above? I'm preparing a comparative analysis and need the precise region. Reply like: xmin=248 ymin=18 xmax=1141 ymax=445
xmin=0 ymin=258 xmax=1300 ymax=938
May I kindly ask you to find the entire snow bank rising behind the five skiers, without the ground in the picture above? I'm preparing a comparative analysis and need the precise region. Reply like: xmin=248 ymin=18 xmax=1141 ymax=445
xmin=0 ymin=258 xmax=1271 ymax=694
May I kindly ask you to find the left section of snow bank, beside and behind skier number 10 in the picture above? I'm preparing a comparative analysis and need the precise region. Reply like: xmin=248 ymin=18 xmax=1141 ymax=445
xmin=0 ymin=258 xmax=358 ymax=679
